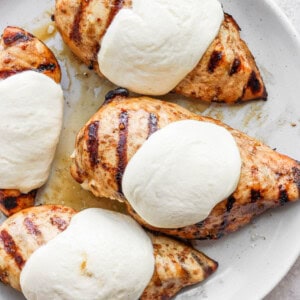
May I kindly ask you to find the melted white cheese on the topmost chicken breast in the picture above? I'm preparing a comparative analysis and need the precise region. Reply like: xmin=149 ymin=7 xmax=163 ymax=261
xmin=98 ymin=0 xmax=224 ymax=95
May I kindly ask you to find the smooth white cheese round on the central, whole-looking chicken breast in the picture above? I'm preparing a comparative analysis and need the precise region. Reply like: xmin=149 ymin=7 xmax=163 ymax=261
xmin=122 ymin=120 xmax=241 ymax=228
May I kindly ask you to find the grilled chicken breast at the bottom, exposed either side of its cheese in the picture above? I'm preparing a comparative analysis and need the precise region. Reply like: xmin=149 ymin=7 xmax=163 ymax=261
xmin=0 ymin=205 xmax=218 ymax=300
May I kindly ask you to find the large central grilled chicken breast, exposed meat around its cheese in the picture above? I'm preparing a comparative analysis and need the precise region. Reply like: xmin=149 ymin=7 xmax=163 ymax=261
xmin=71 ymin=89 xmax=300 ymax=239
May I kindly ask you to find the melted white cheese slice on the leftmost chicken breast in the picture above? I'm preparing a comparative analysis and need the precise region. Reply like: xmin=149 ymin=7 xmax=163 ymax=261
xmin=0 ymin=71 xmax=64 ymax=193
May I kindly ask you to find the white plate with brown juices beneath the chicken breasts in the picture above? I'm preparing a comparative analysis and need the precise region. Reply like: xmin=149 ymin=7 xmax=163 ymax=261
xmin=0 ymin=0 xmax=300 ymax=300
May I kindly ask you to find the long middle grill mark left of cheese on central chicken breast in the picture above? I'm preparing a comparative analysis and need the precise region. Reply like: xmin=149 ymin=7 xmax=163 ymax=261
xmin=115 ymin=110 xmax=129 ymax=193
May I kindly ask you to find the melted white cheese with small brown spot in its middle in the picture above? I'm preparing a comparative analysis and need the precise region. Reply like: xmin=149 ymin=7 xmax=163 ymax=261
xmin=20 ymin=208 xmax=154 ymax=300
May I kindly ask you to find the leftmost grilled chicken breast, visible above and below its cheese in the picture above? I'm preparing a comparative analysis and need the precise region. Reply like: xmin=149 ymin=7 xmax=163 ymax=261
xmin=0 ymin=26 xmax=61 ymax=216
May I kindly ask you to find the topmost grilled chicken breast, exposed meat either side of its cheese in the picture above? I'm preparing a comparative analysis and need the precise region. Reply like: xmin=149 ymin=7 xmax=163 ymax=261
xmin=55 ymin=0 xmax=267 ymax=104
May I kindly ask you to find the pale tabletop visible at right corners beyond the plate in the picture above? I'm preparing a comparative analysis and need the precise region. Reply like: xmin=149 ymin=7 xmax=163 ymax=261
xmin=265 ymin=0 xmax=300 ymax=300
